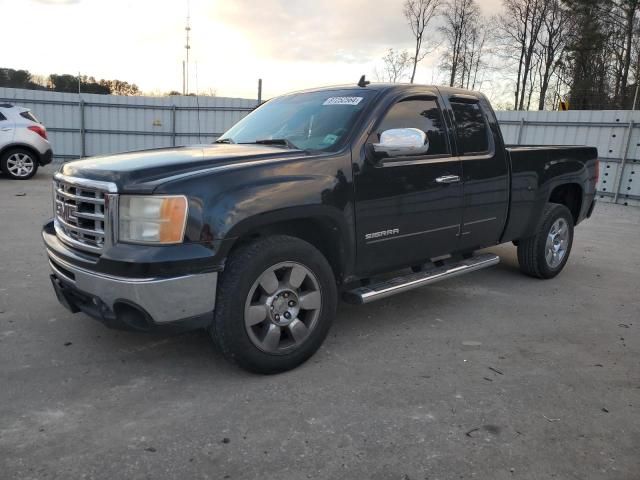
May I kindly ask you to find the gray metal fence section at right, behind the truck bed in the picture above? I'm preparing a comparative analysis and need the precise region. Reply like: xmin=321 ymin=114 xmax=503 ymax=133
xmin=496 ymin=110 xmax=640 ymax=205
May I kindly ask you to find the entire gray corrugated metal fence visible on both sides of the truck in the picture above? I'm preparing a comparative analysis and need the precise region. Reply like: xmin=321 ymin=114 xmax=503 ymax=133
xmin=0 ymin=88 xmax=640 ymax=205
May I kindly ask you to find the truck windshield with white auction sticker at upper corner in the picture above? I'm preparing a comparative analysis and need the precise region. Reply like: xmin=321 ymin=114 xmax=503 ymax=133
xmin=216 ymin=89 xmax=375 ymax=151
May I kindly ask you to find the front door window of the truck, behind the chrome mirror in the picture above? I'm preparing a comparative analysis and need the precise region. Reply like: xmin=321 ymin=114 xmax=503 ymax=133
xmin=369 ymin=98 xmax=449 ymax=155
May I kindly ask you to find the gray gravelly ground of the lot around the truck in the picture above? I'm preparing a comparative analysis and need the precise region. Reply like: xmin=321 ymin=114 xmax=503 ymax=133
xmin=0 ymin=168 xmax=640 ymax=480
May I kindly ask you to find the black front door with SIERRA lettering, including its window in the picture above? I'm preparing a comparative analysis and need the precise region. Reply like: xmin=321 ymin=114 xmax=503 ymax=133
xmin=354 ymin=95 xmax=463 ymax=274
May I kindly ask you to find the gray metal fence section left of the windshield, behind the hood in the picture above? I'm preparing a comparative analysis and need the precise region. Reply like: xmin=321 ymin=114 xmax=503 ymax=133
xmin=0 ymin=88 xmax=257 ymax=161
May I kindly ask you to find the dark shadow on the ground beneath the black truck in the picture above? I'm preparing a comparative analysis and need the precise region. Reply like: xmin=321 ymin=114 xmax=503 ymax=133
xmin=77 ymin=246 xmax=535 ymax=382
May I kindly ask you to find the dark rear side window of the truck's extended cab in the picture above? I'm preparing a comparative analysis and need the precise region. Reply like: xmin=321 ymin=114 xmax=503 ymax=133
xmin=451 ymin=101 xmax=489 ymax=155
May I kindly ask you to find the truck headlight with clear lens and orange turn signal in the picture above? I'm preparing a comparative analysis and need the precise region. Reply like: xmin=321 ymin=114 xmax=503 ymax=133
xmin=118 ymin=195 xmax=188 ymax=244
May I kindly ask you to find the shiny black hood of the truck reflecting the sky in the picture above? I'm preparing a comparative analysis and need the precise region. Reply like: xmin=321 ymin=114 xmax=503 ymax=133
xmin=60 ymin=144 xmax=305 ymax=193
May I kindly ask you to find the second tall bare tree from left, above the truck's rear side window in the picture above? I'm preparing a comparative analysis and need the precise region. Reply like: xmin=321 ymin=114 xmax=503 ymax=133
xmin=440 ymin=0 xmax=480 ymax=87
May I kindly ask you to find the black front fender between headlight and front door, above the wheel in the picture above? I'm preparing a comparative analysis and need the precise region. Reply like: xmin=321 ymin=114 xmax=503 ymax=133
xmin=157 ymin=154 xmax=354 ymax=266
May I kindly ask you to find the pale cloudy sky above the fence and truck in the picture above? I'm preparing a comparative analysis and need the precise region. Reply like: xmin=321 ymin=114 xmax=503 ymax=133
xmin=0 ymin=0 xmax=501 ymax=98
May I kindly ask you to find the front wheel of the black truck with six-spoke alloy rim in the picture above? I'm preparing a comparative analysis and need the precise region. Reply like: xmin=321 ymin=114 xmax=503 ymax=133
xmin=210 ymin=235 xmax=337 ymax=374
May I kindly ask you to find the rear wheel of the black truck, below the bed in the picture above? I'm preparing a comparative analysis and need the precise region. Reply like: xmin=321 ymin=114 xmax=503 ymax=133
xmin=518 ymin=203 xmax=573 ymax=278
